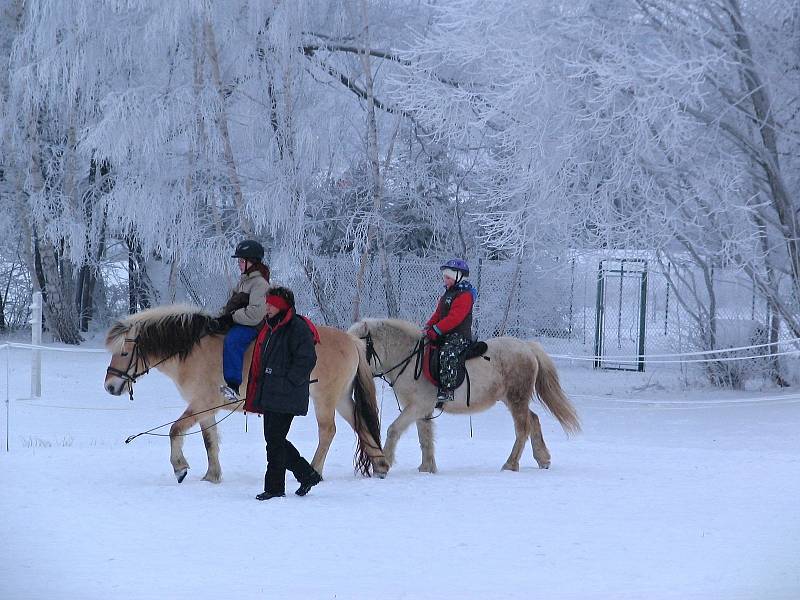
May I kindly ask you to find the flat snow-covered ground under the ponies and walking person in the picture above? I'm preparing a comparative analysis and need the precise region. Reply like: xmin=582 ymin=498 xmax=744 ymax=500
xmin=0 ymin=342 xmax=800 ymax=600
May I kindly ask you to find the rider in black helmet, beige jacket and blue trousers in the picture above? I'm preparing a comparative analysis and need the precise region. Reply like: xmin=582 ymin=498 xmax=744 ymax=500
xmin=213 ymin=240 xmax=269 ymax=401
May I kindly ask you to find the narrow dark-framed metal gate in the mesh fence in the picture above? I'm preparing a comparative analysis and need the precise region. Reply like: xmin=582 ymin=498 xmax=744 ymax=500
xmin=594 ymin=258 xmax=647 ymax=371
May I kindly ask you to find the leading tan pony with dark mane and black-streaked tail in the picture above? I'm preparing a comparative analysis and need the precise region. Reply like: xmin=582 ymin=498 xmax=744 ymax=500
xmin=105 ymin=305 xmax=388 ymax=483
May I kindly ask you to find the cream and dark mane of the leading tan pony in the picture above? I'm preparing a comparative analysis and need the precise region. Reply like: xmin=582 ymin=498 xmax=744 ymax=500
xmin=105 ymin=304 xmax=212 ymax=360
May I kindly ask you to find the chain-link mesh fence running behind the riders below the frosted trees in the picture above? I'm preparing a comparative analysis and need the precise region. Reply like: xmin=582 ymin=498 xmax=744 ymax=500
xmin=177 ymin=254 xmax=792 ymax=387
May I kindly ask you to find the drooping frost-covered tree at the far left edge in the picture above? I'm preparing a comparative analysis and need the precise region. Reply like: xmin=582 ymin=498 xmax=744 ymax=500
xmin=2 ymin=3 xmax=112 ymax=343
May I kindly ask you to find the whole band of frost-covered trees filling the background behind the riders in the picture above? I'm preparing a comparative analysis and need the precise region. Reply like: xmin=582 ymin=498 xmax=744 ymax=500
xmin=0 ymin=0 xmax=800 ymax=368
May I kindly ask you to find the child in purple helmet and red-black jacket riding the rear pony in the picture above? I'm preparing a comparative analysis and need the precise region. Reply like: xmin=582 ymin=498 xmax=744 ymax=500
xmin=423 ymin=258 xmax=478 ymax=408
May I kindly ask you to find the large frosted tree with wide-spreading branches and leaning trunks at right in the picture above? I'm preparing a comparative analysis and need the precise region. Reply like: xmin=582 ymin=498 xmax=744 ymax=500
xmin=396 ymin=0 xmax=798 ymax=376
